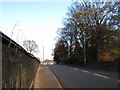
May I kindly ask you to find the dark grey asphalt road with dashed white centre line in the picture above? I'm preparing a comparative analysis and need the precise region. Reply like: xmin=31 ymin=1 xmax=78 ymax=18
xmin=48 ymin=65 xmax=120 ymax=88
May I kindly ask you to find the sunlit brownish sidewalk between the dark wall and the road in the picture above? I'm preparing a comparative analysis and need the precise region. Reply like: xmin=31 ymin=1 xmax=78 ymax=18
xmin=29 ymin=65 xmax=62 ymax=89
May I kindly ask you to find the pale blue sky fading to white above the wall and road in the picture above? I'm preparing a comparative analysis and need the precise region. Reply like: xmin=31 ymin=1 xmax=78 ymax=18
xmin=0 ymin=0 xmax=71 ymax=60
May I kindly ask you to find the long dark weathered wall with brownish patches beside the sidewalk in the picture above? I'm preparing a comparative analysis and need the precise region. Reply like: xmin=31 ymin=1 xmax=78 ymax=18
xmin=1 ymin=33 xmax=40 ymax=88
